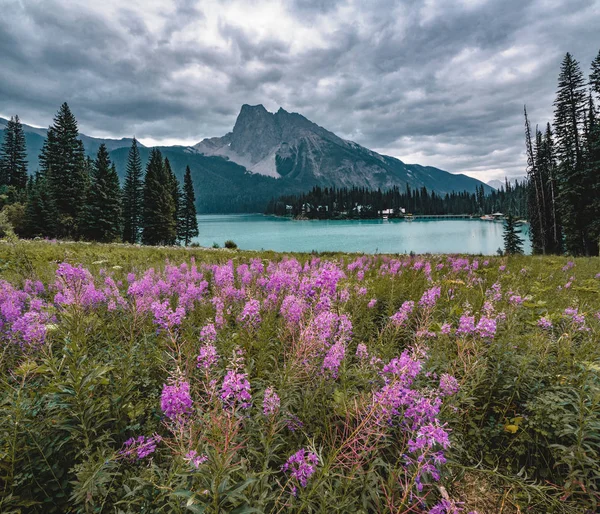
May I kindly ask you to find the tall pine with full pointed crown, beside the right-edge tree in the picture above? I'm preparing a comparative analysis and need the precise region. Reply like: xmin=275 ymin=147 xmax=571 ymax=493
xmin=554 ymin=53 xmax=589 ymax=255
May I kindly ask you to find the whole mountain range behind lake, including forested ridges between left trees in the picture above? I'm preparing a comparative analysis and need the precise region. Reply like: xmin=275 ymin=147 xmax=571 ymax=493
xmin=0 ymin=105 xmax=492 ymax=213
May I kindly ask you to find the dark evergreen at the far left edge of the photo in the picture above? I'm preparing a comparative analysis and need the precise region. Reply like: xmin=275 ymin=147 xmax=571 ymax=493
xmin=0 ymin=116 xmax=28 ymax=191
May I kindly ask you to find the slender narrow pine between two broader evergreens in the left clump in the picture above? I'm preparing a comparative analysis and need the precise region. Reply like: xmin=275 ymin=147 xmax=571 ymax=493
xmin=123 ymin=137 xmax=144 ymax=243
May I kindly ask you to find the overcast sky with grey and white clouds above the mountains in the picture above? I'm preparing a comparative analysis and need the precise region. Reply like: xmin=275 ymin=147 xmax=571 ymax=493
xmin=0 ymin=0 xmax=600 ymax=181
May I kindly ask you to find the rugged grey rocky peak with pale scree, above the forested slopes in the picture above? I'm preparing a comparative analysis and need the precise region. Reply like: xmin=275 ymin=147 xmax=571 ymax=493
xmin=193 ymin=104 xmax=491 ymax=194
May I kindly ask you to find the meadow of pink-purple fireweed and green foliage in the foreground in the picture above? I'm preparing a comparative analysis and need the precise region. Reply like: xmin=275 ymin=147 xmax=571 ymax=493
xmin=0 ymin=241 xmax=600 ymax=514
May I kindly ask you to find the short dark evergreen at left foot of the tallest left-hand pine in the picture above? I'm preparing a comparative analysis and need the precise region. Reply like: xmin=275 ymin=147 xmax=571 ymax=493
xmin=25 ymin=172 xmax=58 ymax=237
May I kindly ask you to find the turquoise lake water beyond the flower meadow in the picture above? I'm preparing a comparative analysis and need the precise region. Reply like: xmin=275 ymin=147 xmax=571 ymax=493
xmin=195 ymin=214 xmax=531 ymax=255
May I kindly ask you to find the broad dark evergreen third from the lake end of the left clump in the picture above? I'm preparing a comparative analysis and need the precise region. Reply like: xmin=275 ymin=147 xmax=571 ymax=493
xmin=142 ymin=148 xmax=177 ymax=245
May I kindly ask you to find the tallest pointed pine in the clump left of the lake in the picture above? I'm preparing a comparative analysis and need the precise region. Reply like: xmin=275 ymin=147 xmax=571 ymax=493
xmin=40 ymin=103 xmax=88 ymax=237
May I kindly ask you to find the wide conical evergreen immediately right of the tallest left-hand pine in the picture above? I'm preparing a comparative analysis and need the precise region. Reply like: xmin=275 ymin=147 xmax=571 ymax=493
xmin=81 ymin=144 xmax=121 ymax=243
